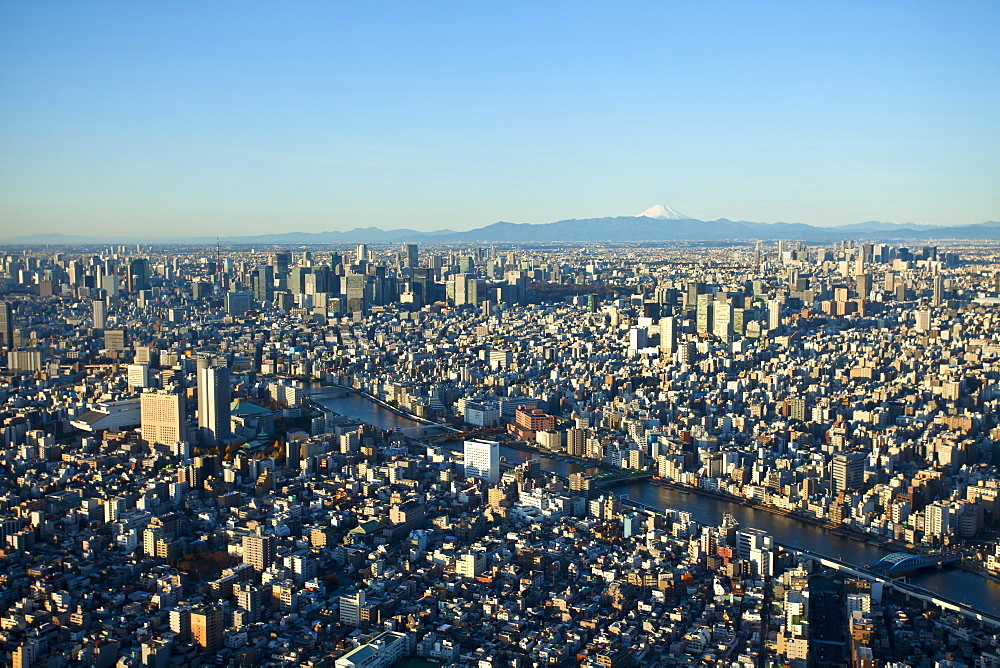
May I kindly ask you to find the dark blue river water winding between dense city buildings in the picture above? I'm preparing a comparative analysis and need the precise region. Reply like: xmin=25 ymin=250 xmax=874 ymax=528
xmin=317 ymin=395 xmax=1000 ymax=615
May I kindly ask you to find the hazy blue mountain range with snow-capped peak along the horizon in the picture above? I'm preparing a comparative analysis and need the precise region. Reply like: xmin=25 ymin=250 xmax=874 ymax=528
xmin=6 ymin=204 xmax=1000 ymax=245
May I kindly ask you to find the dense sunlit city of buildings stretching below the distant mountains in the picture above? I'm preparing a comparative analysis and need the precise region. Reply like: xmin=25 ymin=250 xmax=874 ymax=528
xmin=0 ymin=241 xmax=1000 ymax=668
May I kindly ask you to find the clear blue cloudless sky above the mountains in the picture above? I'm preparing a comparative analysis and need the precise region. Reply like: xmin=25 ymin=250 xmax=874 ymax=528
xmin=0 ymin=0 xmax=1000 ymax=237
